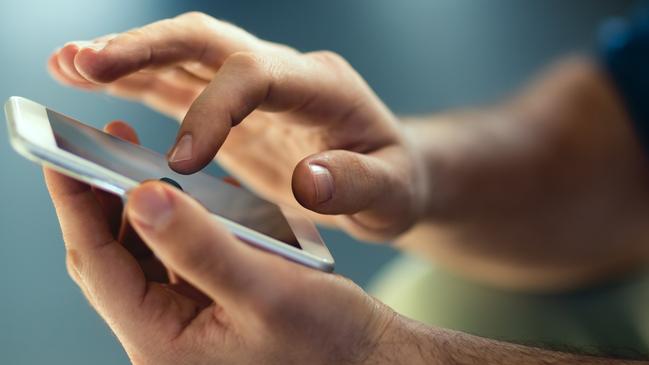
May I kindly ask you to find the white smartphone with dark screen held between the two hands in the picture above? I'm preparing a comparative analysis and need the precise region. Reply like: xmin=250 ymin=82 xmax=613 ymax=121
xmin=5 ymin=96 xmax=334 ymax=272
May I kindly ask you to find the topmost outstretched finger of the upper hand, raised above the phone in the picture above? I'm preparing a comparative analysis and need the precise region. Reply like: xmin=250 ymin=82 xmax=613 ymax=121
xmin=69 ymin=12 xmax=259 ymax=83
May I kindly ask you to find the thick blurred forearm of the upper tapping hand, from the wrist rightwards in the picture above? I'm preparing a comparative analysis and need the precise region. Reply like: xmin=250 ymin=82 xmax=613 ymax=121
xmin=398 ymin=58 xmax=647 ymax=290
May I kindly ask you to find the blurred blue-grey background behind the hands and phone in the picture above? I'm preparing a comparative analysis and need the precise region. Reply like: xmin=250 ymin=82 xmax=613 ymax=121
xmin=0 ymin=0 xmax=630 ymax=365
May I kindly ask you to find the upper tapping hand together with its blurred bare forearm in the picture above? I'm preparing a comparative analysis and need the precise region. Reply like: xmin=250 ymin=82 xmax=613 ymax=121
xmin=50 ymin=13 xmax=649 ymax=289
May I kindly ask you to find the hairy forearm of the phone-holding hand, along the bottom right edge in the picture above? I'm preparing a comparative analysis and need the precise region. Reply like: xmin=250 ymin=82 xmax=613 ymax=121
xmin=365 ymin=317 xmax=649 ymax=365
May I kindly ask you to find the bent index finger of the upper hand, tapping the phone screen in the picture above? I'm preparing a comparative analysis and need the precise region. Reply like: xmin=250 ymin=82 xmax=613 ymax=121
xmin=169 ymin=51 xmax=380 ymax=174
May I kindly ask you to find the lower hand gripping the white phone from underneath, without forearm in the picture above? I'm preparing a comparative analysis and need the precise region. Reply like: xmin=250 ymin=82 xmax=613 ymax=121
xmin=45 ymin=122 xmax=394 ymax=365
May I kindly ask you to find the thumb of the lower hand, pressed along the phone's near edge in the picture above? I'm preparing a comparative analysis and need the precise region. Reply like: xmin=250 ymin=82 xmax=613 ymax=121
xmin=126 ymin=182 xmax=281 ymax=308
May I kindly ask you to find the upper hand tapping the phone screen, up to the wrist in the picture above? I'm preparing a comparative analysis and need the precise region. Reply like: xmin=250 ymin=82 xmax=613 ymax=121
xmin=49 ymin=13 xmax=427 ymax=240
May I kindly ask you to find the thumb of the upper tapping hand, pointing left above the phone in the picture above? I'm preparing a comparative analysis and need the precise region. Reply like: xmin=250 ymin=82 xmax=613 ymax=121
xmin=292 ymin=147 xmax=414 ymax=236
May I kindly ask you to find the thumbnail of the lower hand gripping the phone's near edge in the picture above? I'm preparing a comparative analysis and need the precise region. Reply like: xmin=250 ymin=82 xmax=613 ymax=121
xmin=128 ymin=186 xmax=172 ymax=230
